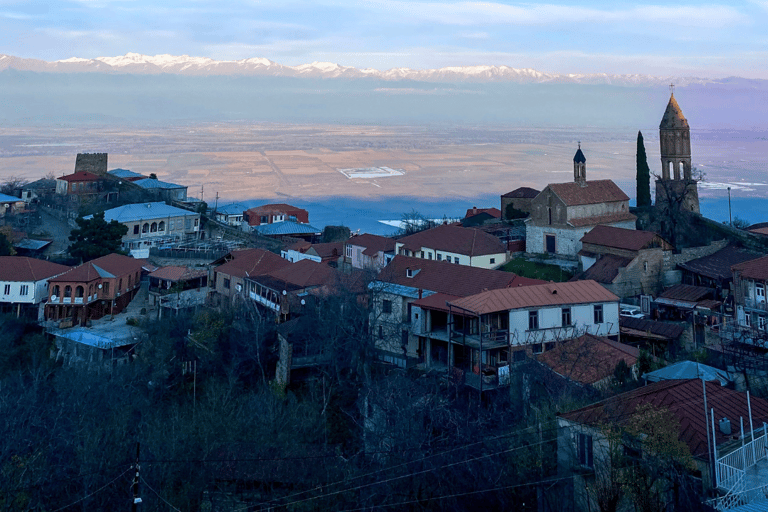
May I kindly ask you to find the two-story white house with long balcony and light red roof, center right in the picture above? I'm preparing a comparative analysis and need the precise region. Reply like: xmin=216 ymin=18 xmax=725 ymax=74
xmin=412 ymin=281 xmax=619 ymax=391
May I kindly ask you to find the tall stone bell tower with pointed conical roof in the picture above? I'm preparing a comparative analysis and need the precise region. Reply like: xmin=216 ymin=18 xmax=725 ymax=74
xmin=656 ymin=93 xmax=699 ymax=213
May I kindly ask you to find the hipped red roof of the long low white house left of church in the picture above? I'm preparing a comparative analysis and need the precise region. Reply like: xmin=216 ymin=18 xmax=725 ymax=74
xmin=398 ymin=225 xmax=506 ymax=256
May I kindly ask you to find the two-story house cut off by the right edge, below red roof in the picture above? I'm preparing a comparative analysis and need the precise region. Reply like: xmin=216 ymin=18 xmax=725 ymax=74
xmin=731 ymin=256 xmax=768 ymax=336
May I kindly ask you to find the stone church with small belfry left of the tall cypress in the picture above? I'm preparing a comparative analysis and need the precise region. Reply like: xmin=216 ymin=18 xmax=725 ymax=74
xmin=525 ymin=146 xmax=637 ymax=258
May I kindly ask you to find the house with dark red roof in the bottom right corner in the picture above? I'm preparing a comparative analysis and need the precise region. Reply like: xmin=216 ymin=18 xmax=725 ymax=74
xmin=557 ymin=379 xmax=768 ymax=510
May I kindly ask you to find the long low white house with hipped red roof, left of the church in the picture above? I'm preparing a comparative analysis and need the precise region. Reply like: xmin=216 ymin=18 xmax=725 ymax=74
xmin=395 ymin=224 xmax=508 ymax=269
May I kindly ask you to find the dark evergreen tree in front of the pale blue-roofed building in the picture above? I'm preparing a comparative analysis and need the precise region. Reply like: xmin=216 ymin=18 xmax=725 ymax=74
xmin=69 ymin=212 xmax=128 ymax=262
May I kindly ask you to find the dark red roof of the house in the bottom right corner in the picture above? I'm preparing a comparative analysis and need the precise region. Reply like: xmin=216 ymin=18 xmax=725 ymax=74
xmin=561 ymin=379 xmax=768 ymax=460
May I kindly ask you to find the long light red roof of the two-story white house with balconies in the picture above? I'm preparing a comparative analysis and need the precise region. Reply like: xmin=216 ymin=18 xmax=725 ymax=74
xmin=451 ymin=281 xmax=619 ymax=314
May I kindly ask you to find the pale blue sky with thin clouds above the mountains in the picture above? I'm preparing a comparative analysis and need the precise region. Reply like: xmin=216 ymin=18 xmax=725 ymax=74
xmin=0 ymin=0 xmax=768 ymax=78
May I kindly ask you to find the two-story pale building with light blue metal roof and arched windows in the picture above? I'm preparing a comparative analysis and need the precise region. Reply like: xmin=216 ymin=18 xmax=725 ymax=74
xmin=85 ymin=202 xmax=200 ymax=256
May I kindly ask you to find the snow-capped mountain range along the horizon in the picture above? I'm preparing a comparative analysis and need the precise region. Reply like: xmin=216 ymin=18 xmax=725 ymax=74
xmin=0 ymin=53 xmax=719 ymax=86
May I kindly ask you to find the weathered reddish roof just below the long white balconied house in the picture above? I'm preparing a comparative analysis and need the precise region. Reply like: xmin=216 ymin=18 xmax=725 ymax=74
xmin=538 ymin=334 xmax=640 ymax=385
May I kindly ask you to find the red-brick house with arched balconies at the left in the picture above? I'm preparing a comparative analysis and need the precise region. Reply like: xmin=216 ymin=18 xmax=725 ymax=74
xmin=45 ymin=253 xmax=143 ymax=325
